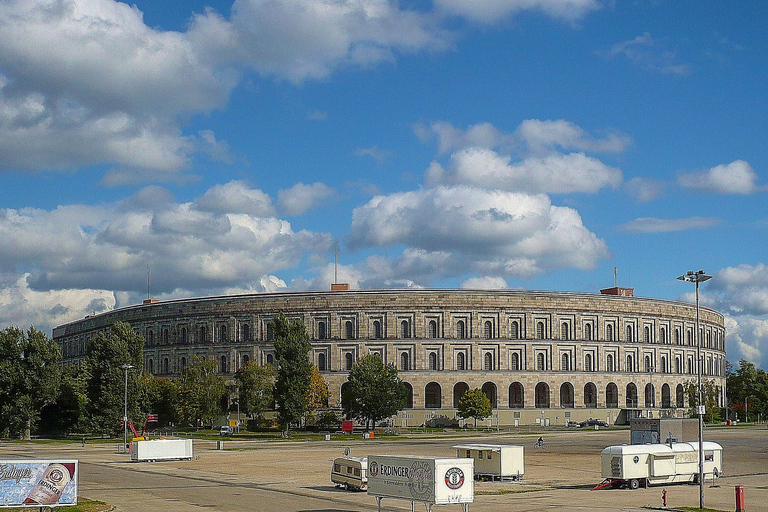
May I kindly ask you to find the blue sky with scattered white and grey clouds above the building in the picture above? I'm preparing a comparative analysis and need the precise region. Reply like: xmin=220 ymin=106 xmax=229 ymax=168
xmin=0 ymin=0 xmax=768 ymax=368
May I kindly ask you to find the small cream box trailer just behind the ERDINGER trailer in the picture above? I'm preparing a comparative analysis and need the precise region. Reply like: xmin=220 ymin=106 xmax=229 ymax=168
xmin=452 ymin=444 xmax=525 ymax=480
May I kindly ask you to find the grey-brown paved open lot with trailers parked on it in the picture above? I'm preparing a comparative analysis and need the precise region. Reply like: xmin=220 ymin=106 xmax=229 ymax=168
xmin=0 ymin=427 xmax=768 ymax=512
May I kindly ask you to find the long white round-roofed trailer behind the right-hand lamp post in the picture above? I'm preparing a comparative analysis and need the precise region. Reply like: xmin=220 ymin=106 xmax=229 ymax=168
xmin=600 ymin=441 xmax=723 ymax=489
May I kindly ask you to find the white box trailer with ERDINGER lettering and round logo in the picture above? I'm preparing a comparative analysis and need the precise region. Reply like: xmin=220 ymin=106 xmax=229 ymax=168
xmin=368 ymin=455 xmax=475 ymax=512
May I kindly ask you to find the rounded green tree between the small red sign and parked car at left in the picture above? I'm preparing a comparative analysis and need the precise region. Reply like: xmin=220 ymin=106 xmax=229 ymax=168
xmin=179 ymin=356 xmax=222 ymax=426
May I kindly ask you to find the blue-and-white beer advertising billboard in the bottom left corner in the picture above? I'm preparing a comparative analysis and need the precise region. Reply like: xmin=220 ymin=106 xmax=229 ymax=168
xmin=0 ymin=460 xmax=78 ymax=508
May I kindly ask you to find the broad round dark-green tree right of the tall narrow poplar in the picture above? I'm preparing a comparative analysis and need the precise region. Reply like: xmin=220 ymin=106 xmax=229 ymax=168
xmin=341 ymin=354 xmax=408 ymax=428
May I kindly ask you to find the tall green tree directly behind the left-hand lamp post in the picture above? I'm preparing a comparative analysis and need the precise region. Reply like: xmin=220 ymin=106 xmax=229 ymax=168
xmin=86 ymin=322 xmax=144 ymax=436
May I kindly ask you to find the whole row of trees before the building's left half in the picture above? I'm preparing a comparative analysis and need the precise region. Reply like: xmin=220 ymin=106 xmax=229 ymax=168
xmin=0 ymin=315 xmax=416 ymax=439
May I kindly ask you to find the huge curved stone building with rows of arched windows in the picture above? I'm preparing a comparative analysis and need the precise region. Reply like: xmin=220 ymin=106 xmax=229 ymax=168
xmin=53 ymin=288 xmax=725 ymax=426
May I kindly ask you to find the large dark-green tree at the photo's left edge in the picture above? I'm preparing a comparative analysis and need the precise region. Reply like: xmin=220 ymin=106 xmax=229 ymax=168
xmin=0 ymin=327 xmax=61 ymax=439
